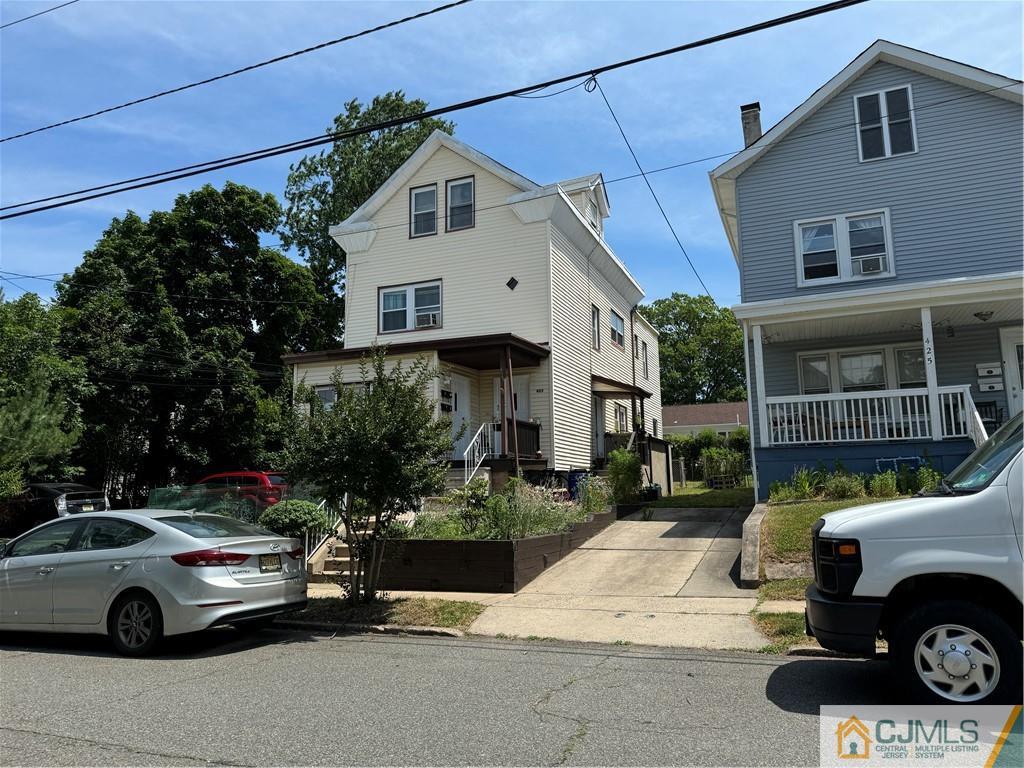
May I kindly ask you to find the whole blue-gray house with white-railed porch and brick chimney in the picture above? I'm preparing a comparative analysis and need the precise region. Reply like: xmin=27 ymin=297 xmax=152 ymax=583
xmin=711 ymin=40 xmax=1024 ymax=499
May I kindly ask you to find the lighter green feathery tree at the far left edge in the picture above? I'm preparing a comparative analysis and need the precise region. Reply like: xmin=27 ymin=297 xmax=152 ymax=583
xmin=0 ymin=292 xmax=89 ymax=499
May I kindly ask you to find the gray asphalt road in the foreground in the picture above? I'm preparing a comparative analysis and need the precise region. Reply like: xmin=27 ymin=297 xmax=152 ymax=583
xmin=0 ymin=629 xmax=890 ymax=766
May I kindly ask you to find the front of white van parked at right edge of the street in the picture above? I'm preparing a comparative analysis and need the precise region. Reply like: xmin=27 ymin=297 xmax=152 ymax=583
xmin=806 ymin=414 xmax=1024 ymax=703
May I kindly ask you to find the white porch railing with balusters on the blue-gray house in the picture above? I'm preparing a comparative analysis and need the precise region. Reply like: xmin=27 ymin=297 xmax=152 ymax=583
xmin=765 ymin=386 xmax=985 ymax=445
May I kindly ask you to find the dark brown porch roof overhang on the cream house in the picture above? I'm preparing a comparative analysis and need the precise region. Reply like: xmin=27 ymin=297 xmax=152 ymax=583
xmin=282 ymin=334 xmax=551 ymax=370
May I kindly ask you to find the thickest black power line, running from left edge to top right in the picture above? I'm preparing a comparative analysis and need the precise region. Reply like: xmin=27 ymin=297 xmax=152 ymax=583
xmin=0 ymin=0 xmax=866 ymax=220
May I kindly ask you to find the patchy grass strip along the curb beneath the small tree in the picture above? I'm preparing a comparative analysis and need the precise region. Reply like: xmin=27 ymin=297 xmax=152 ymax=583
xmin=288 ymin=597 xmax=484 ymax=630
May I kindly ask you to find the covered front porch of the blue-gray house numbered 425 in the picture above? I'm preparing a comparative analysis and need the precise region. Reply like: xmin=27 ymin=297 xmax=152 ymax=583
xmin=735 ymin=276 xmax=1024 ymax=498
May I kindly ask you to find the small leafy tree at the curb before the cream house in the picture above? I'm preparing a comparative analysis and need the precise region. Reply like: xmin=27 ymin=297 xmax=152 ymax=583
xmin=285 ymin=346 xmax=453 ymax=603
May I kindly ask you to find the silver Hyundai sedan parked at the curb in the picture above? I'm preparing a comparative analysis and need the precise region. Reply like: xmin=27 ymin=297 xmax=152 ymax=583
xmin=0 ymin=509 xmax=306 ymax=655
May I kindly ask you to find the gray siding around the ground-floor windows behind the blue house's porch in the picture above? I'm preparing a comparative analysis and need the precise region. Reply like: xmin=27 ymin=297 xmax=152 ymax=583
xmin=750 ymin=325 xmax=1009 ymax=439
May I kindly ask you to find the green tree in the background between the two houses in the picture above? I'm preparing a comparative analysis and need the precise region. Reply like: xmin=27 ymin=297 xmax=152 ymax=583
xmin=641 ymin=293 xmax=746 ymax=404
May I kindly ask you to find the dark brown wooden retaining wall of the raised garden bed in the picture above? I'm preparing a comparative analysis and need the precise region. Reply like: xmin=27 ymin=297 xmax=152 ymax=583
xmin=381 ymin=510 xmax=615 ymax=592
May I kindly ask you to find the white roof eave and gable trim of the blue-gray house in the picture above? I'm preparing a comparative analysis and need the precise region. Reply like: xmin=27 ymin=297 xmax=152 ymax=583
xmin=709 ymin=40 xmax=1024 ymax=264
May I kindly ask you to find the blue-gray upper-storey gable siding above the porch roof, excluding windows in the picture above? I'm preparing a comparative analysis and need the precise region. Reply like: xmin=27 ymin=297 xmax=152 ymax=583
xmin=736 ymin=62 xmax=1024 ymax=302
